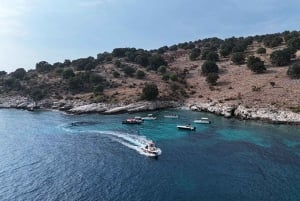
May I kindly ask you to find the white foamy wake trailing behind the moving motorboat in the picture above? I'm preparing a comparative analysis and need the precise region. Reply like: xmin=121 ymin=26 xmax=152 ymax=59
xmin=63 ymin=124 xmax=162 ymax=156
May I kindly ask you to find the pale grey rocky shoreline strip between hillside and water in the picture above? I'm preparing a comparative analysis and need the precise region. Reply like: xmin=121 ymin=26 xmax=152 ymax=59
xmin=0 ymin=96 xmax=300 ymax=125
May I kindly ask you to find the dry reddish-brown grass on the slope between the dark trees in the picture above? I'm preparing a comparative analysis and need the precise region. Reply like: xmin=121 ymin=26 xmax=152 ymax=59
xmin=43 ymin=43 xmax=300 ymax=112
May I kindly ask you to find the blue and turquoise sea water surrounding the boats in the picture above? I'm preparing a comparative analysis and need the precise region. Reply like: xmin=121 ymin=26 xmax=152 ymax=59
xmin=0 ymin=109 xmax=300 ymax=201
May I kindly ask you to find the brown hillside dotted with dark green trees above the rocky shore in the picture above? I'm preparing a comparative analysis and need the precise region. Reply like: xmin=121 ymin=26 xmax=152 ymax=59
xmin=0 ymin=31 xmax=300 ymax=112
